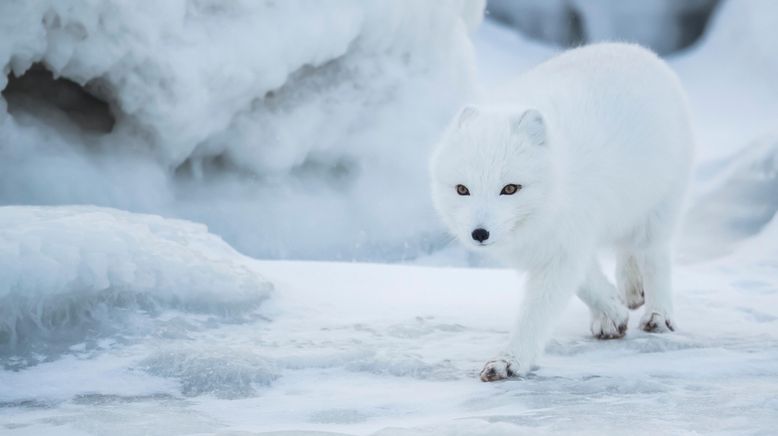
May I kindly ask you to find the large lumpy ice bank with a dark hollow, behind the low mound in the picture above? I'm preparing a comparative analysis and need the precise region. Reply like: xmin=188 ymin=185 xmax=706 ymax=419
xmin=0 ymin=0 xmax=483 ymax=259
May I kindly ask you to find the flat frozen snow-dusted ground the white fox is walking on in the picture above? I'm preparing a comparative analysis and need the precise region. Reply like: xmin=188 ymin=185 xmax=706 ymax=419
xmin=0 ymin=255 xmax=778 ymax=435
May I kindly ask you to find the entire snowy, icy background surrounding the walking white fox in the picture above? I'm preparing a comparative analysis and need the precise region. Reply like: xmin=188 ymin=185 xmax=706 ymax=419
xmin=0 ymin=0 xmax=778 ymax=436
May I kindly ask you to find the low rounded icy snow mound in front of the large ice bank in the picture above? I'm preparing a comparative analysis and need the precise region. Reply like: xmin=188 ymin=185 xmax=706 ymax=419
xmin=0 ymin=207 xmax=271 ymax=366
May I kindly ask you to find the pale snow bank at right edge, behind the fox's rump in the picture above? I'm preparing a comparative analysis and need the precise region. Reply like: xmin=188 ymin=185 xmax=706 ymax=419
xmin=673 ymin=0 xmax=778 ymax=259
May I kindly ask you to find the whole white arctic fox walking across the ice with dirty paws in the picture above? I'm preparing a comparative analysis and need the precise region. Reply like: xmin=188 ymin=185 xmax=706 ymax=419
xmin=430 ymin=43 xmax=693 ymax=381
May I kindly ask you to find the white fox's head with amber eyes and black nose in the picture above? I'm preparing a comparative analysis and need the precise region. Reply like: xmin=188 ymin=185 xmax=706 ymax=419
xmin=430 ymin=106 xmax=552 ymax=250
